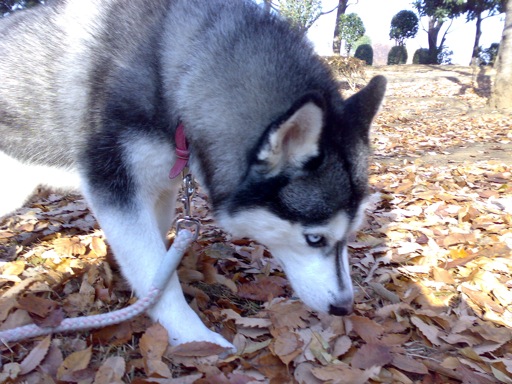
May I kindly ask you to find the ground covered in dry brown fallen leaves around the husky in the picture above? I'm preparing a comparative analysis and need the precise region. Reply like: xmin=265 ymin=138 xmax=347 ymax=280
xmin=0 ymin=66 xmax=512 ymax=384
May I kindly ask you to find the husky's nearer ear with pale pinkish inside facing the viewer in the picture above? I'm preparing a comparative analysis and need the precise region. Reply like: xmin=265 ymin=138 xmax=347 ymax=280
xmin=257 ymin=94 xmax=325 ymax=176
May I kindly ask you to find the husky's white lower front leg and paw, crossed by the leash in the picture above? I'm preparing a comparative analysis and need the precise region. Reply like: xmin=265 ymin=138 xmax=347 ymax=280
xmin=85 ymin=186 xmax=234 ymax=351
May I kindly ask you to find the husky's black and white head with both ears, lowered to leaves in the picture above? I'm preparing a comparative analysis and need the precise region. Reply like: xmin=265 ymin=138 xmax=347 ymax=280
xmin=218 ymin=76 xmax=386 ymax=315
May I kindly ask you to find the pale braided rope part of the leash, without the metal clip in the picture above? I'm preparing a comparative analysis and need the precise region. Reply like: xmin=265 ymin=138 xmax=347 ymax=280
xmin=0 ymin=229 xmax=196 ymax=343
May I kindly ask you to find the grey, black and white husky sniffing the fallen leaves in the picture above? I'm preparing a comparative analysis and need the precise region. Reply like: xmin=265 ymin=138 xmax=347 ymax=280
xmin=0 ymin=0 xmax=386 ymax=348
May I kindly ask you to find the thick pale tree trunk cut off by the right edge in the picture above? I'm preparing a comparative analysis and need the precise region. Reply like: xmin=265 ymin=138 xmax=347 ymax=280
xmin=489 ymin=0 xmax=512 ymax=111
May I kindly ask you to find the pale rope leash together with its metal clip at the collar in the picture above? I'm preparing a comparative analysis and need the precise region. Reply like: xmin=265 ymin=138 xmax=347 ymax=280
xmin=0 ymin=174 xmax=200 ymax=344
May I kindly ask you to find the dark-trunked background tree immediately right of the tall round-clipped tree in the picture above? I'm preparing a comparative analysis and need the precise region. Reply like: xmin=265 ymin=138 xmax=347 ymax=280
xmin=413 ymin=0 xmax=465 ymax=64
